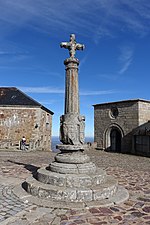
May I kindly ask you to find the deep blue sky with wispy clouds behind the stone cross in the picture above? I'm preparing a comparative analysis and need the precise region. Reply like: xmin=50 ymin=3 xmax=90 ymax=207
xmin=0 ymin=0 xmax=150 ymax=136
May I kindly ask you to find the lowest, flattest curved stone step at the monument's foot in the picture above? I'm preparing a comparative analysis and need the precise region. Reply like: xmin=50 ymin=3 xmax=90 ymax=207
xmin=13 ymin=185 xmax=129 ymax=210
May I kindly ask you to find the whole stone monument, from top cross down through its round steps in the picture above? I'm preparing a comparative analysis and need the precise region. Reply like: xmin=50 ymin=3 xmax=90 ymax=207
xmin=25 ymin=34 xmax=129 ymax=208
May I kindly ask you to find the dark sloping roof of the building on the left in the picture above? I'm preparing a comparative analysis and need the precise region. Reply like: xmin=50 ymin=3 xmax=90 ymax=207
xmin=0 ymin=87 xmax=54 ymax=114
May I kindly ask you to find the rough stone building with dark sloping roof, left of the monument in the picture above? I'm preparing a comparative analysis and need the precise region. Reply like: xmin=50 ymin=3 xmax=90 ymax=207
xmin=0 ymin=87 xmax=53 ymax=150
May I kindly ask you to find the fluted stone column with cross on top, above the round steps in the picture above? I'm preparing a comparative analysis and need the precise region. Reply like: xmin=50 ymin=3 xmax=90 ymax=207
xmin=59 ymin=34 xmax=85 ymax=146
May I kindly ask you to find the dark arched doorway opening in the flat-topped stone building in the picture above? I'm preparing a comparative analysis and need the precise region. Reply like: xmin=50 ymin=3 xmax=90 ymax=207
xmin=110 ymin=128 xmax=122 ymax=152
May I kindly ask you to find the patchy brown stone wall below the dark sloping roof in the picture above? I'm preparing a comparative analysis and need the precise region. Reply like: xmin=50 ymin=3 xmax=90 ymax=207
xmin=0 ymin=107 xmax=52 ymax=150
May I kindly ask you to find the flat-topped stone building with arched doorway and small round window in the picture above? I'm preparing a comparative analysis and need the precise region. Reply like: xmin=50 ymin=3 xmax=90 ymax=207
xmin=94 ymin=99 xmax=150 ymax=155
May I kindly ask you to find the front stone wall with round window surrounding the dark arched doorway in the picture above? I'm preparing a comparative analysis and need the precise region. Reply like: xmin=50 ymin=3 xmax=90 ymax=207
xmin=94 ymin=100 xmax=138 ymax=152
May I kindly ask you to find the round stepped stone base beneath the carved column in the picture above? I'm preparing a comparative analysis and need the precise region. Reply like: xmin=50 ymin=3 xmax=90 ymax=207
xmin=24 ymin=149 xmax=129 ymax=205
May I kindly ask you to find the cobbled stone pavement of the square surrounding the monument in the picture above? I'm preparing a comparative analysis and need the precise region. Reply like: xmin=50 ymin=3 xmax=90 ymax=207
xmin=0 ymin=150 xmax=150 ymax=225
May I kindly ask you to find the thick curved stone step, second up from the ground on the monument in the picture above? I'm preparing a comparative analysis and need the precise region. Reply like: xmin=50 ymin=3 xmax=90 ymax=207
xmin=26 ymin=172 xmax=118 ymax=202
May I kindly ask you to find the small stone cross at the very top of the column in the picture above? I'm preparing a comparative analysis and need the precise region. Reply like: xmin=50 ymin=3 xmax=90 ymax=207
xmin=60 ymin=34 xmax=85 ymax=58
